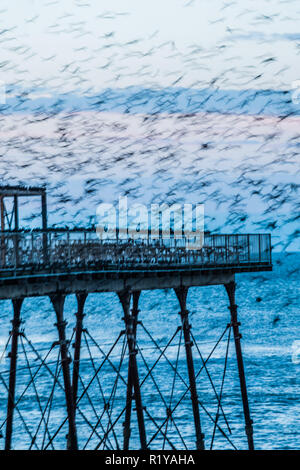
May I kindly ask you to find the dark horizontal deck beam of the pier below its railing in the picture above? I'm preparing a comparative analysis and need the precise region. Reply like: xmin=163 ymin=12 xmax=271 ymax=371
xmin=0 ymin=263 xmax=272 ymax=299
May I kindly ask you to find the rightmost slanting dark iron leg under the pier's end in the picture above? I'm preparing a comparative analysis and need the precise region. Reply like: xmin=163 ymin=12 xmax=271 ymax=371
xmin=225 ymin=281 xmax=254 ymax=450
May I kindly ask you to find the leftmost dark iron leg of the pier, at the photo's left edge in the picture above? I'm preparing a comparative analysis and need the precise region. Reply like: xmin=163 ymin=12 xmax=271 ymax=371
xmin=5 ymin=299 xmax=23 ymax=450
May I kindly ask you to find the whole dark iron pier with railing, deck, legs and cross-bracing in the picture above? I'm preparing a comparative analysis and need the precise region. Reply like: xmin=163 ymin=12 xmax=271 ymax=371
xmin=0 ymin=186 xmax=272 ymax=450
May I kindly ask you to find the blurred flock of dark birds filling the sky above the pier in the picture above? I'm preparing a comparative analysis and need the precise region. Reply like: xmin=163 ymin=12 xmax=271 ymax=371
xmin=0 ymin=0 xmax=300 ymax=260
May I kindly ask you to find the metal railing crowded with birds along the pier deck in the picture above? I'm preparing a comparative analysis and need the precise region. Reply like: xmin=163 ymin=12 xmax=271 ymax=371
xmin=0 ymin=229 xmax=271 ymax=271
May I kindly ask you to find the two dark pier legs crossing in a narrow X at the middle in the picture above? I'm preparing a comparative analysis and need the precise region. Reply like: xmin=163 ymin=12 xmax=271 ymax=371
xmin=118 ymin=291 xmax=147 ymax=450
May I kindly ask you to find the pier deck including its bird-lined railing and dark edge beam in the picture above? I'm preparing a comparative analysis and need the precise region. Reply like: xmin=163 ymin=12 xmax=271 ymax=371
xmin=0 ymin=230 xmax=272 ymax=299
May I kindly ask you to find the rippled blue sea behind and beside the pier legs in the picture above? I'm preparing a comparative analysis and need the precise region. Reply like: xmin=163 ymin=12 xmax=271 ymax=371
xmin=0 ymin=253 xmax=300 ymax=449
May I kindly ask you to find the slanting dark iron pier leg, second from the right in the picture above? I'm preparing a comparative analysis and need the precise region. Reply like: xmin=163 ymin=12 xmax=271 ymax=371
xmin=174 ymin=287 xmax=204 ymax=450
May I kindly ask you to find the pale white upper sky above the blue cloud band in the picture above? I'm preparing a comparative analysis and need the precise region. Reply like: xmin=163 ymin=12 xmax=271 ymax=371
xmin=0 ymin=0 xmax=300 ymax=91
